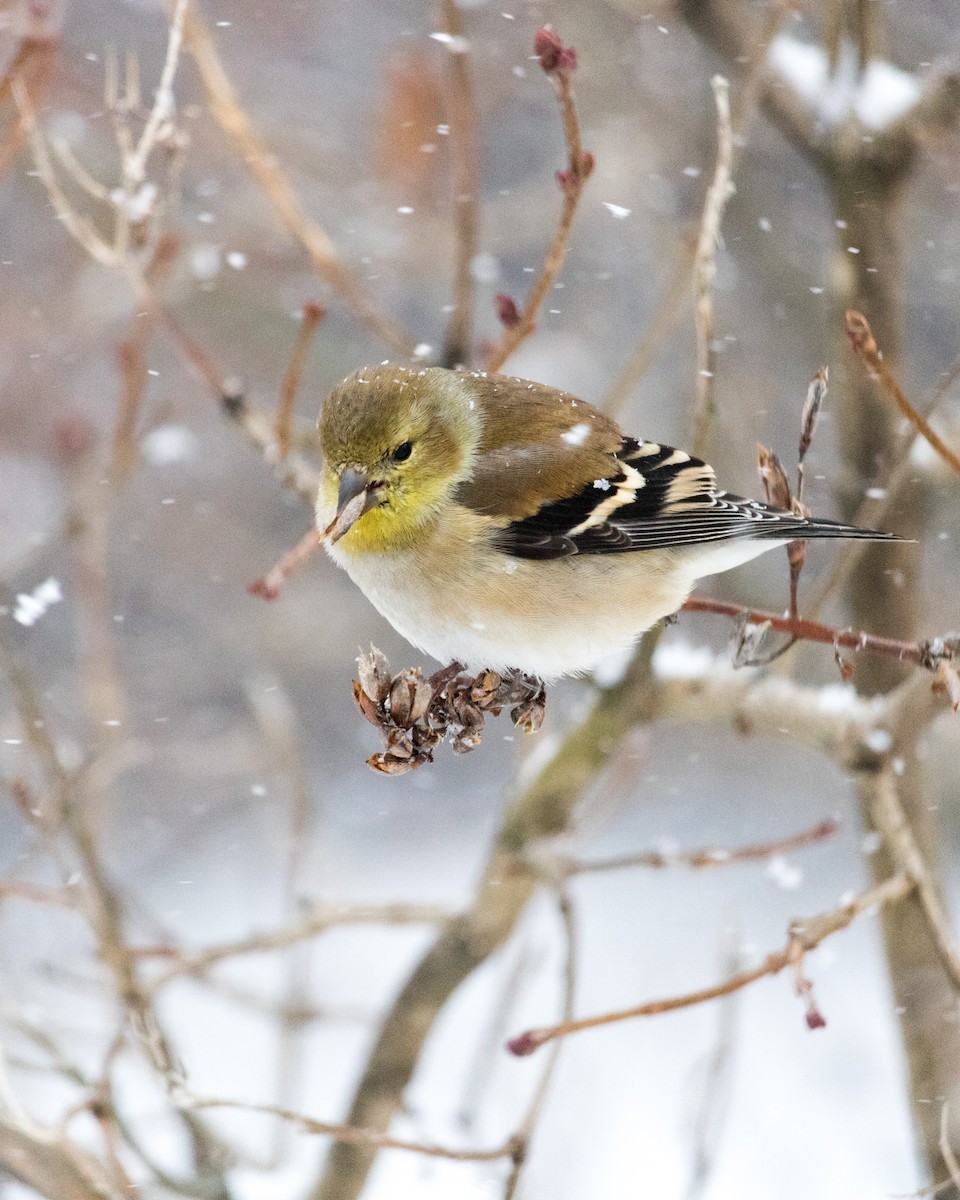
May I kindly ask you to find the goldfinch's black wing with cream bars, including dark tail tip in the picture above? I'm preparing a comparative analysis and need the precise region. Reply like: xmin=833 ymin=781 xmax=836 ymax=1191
xmin=493 ymin=438 xmax=895 ymax=559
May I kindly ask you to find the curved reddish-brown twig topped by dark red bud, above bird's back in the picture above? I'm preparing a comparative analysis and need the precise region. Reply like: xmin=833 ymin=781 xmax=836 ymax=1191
xmin=486 ymin=26 xmax=594 ymax=371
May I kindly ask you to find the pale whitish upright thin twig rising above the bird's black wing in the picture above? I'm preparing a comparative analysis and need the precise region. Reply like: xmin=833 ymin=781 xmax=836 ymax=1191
xmin=694 ymin=74 xmax=736 ymax=455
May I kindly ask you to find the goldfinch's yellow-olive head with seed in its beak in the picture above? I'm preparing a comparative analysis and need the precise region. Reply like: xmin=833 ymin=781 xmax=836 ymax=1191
xmin=318 ymin=366 xmax=480 ymax=550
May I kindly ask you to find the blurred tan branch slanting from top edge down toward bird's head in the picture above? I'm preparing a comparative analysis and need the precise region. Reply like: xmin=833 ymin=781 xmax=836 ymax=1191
xmin=174 ymin=0 xmax=414 ymax=354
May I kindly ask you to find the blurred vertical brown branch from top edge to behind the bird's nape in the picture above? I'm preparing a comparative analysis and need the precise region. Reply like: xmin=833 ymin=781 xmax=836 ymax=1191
xmin=440 ymin=0 xmax=480 ymax=367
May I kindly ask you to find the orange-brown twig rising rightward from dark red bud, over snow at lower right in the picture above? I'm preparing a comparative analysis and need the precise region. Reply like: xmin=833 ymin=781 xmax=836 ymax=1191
xmin=508 ymin=875 xmax=914 ymax=1056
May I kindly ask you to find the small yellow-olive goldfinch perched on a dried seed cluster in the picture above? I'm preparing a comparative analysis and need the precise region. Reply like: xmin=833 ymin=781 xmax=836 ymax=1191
xmin=317 ymin=366 xmax=890 ymax=680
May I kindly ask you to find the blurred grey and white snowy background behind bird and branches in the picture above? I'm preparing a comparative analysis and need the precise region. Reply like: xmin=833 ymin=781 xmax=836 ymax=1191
xmin=0 ymin=0 xmax=960 ymax=1200
